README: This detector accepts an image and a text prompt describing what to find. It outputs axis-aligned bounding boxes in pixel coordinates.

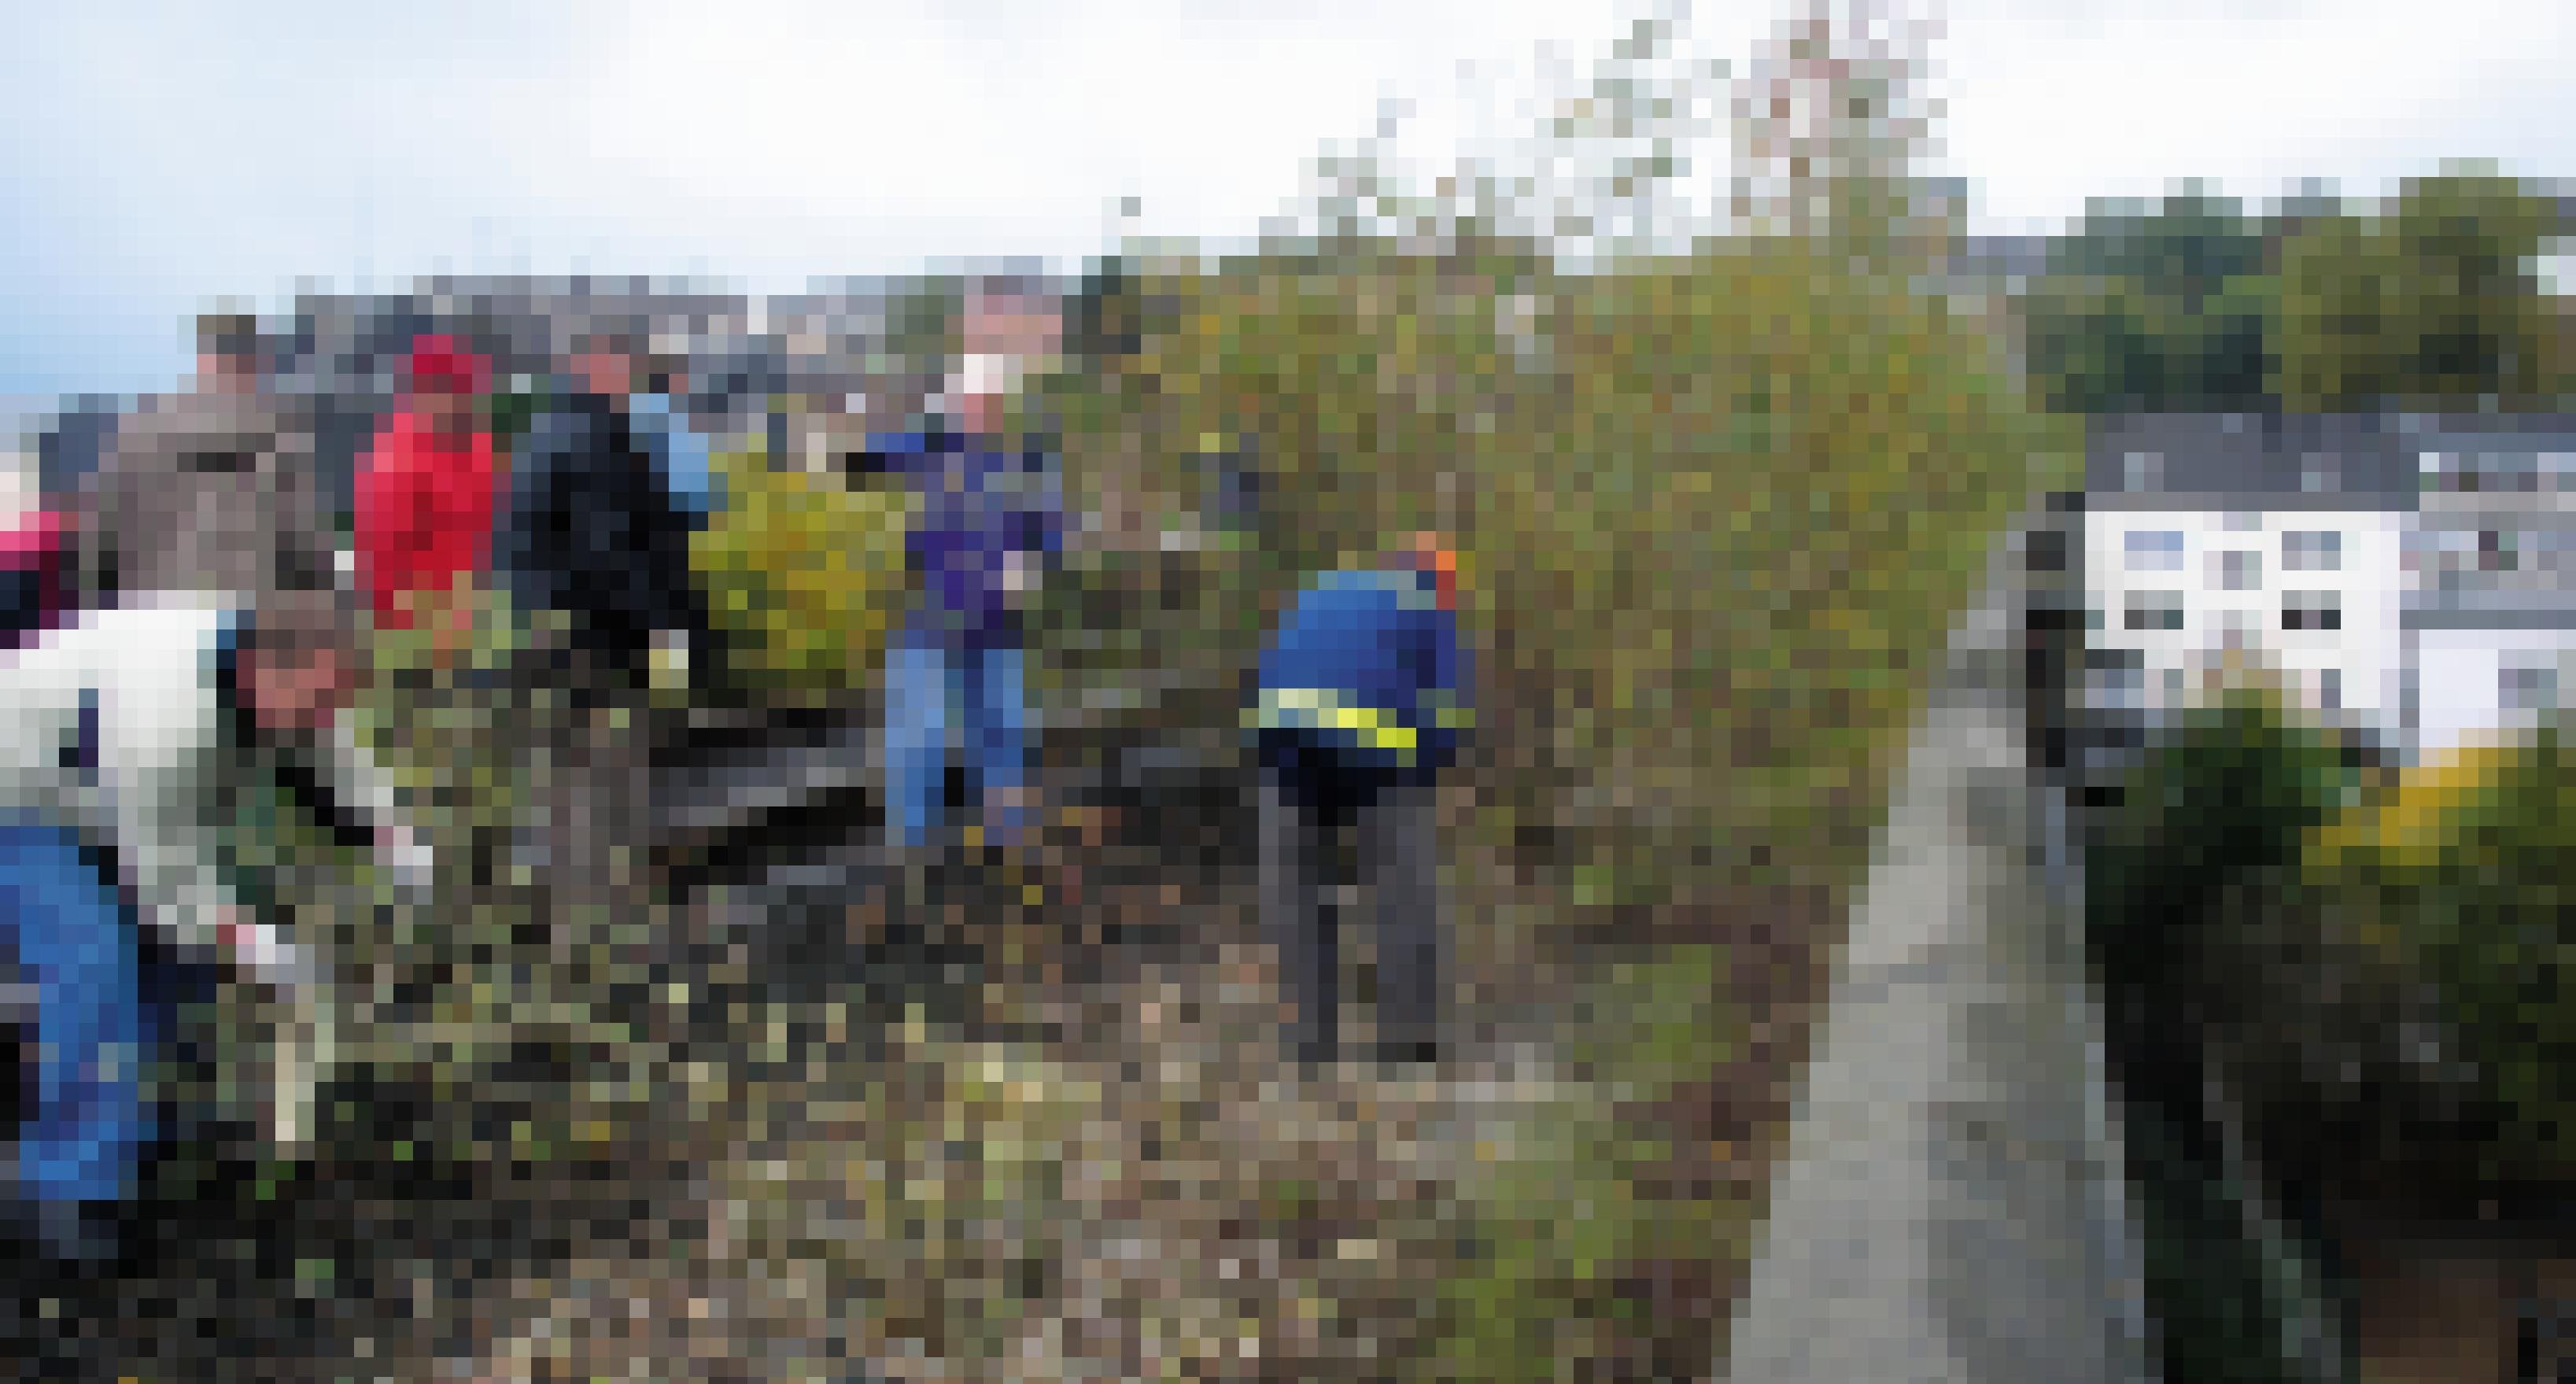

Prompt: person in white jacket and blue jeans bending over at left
[0,592,427,1257]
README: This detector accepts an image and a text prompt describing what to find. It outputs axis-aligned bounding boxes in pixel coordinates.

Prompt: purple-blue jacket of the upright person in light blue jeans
[868,433,1064,649]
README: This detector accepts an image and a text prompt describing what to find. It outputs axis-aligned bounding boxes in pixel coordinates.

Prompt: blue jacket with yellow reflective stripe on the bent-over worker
[1247,562,1474,773]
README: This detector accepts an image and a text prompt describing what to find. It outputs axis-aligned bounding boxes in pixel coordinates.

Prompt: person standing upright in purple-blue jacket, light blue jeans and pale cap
[868,275,1064,853]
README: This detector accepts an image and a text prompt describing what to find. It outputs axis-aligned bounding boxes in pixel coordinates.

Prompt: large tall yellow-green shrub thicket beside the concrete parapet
[1061,245,2074,902]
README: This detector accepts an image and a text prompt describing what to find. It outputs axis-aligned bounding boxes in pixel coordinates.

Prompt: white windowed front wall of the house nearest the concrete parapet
[2084,511,2408,735]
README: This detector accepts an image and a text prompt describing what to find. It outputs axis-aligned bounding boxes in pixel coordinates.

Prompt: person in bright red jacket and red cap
[353,335,495,655]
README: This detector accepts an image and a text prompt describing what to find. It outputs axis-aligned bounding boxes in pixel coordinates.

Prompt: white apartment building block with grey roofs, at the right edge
[2084,415,2576,758]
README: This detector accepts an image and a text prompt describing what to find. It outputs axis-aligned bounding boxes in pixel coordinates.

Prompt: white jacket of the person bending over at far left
[0,596,425,980]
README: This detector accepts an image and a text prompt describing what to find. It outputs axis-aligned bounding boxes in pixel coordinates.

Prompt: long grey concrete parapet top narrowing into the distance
[1718,515,2151,1384]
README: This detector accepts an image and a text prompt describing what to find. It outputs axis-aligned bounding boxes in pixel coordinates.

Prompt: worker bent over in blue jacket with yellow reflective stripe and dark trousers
[1247,533,1471,1065]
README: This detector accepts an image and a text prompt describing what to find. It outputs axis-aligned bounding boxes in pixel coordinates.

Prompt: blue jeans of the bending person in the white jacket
[0,822,157,1201]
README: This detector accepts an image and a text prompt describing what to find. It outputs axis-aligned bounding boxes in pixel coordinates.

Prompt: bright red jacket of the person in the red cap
[350,410,495,629]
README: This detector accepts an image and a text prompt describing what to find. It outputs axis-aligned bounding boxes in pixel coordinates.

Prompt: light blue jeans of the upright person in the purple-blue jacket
[886,634,1028,848]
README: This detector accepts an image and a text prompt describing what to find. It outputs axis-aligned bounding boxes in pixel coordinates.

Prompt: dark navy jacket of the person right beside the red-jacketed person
[495,394,706,667]
